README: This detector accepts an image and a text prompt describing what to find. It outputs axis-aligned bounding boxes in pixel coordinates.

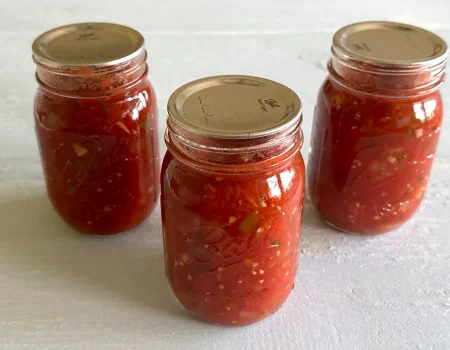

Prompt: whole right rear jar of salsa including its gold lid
[308,22,448,234]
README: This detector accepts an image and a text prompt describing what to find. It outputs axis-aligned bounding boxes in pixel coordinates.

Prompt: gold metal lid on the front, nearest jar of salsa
[167,75,302,139]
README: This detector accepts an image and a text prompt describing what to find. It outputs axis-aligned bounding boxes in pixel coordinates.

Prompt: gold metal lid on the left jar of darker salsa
[32,23,144,68]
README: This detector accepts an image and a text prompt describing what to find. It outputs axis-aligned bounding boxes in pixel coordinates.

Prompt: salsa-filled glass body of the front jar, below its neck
[161,144,305,326]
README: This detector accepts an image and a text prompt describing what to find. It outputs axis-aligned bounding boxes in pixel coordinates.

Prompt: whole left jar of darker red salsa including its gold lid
[33,23,159,234]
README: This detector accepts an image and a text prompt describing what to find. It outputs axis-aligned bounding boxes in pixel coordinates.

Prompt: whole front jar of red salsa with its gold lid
[161,76,305,325]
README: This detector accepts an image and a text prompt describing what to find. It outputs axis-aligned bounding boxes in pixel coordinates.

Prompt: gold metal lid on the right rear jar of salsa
[333,21,448,67]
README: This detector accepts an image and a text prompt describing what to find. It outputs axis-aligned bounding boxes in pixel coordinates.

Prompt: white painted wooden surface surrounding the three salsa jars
[0,0,450,350]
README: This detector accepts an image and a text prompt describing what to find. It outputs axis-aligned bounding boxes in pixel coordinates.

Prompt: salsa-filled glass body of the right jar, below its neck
[308,74,443,234]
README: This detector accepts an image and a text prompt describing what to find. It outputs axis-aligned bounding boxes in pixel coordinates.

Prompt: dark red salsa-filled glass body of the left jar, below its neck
[34,75,159,234]
